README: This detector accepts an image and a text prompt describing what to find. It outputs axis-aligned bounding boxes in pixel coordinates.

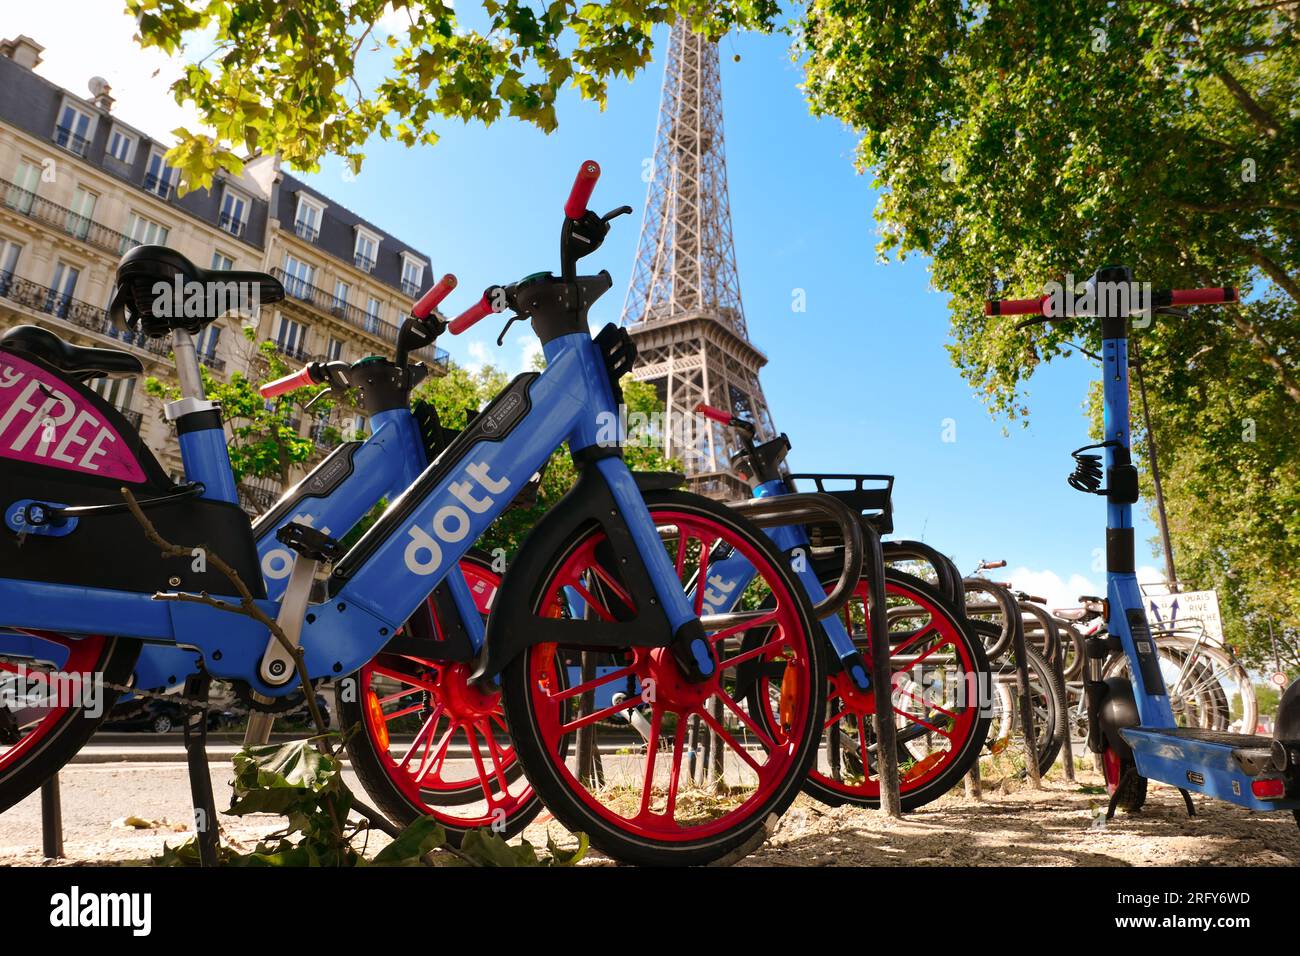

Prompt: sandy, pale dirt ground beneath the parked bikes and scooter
[0,765,1300,866]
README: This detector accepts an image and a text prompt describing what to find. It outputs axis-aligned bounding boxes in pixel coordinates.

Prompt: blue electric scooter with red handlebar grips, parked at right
[985,267,1300,822]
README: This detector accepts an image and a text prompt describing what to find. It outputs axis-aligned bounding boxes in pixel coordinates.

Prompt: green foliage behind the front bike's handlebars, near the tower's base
[412,359,681,557]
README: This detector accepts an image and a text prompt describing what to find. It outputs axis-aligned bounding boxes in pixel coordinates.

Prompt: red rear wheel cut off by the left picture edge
[0,631,140,810]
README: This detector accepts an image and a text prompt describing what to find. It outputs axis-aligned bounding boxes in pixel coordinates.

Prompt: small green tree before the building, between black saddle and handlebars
[144,328,361,488]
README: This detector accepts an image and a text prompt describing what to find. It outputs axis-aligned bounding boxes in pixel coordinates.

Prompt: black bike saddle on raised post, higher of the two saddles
[108,246,285,338]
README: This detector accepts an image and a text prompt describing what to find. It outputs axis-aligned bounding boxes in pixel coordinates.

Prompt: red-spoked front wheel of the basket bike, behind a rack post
[805,571,991,810]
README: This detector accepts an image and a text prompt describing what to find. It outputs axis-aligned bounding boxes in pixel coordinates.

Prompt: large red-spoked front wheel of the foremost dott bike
[503,492,824,865]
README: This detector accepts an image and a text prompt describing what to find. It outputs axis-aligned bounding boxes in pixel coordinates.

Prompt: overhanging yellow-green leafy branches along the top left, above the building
[126,0,779,189]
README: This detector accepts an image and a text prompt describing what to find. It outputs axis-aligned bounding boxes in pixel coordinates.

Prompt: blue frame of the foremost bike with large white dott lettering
[0,333,696,697]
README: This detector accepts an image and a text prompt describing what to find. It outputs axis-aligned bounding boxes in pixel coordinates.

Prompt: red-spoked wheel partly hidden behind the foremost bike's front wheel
[342,557,540,840]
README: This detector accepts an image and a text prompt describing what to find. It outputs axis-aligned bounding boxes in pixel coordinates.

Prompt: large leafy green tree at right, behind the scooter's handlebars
[796,0,1300,660]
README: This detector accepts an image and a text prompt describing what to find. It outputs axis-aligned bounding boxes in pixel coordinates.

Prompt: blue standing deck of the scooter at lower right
[1119,727,1300,810]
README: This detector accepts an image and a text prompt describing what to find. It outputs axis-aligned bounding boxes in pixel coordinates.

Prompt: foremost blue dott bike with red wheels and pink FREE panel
[0,163,824,864]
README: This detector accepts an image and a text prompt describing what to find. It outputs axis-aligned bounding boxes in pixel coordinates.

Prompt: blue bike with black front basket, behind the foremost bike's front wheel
[696,405,991,810]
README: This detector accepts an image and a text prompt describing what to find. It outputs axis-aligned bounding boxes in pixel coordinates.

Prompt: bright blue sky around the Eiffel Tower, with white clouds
[15,0,1158,602]
